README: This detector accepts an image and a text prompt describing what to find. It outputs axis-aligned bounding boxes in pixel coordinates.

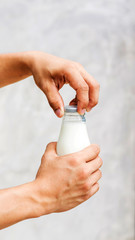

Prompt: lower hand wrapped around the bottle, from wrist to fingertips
[34,143,102,215]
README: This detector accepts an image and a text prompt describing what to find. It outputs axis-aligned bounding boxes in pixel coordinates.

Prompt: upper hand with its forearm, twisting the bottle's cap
[0,51,99,117]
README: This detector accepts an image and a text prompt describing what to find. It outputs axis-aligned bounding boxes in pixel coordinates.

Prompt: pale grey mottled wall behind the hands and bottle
[0,0,135,240]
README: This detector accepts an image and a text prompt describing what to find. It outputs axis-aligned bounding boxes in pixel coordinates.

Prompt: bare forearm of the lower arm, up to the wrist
[0,182,41,229]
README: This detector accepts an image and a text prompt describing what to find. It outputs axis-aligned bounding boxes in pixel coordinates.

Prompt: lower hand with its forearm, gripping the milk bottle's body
[0,142,102,229]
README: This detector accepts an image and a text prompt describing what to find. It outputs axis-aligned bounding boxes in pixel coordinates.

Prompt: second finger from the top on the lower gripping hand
[87,156,103,175]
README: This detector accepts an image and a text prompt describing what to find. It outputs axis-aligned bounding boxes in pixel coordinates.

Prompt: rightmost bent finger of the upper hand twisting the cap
[84,71,100,111]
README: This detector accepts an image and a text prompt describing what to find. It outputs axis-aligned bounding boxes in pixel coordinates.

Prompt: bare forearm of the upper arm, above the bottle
[0,52,32,87]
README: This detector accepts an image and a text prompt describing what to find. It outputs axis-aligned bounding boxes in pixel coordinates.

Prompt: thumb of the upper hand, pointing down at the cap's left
[42,80,64,117]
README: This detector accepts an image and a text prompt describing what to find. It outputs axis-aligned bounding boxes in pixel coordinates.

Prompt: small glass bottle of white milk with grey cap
[56,105,90,156]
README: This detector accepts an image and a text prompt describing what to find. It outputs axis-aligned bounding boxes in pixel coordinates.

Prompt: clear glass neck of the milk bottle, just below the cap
[63,112,86,123]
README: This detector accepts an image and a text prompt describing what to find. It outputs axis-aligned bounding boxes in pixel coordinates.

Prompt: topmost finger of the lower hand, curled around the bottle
[67,144,100,162]
